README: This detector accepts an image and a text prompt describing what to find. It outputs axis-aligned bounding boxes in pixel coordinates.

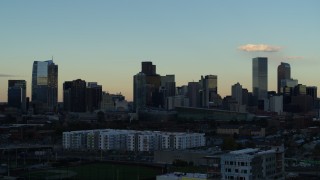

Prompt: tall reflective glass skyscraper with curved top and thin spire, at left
[32,60,58,111]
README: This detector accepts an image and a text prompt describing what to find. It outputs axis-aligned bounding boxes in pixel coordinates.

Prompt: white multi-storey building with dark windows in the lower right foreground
[221,147,284,180]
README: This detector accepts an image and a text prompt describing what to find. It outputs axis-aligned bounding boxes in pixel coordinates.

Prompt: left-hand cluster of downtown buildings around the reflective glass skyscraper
[4,60,128,114]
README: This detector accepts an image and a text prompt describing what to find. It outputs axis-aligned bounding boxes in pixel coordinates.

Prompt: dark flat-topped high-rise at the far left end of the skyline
[8,80,27,112]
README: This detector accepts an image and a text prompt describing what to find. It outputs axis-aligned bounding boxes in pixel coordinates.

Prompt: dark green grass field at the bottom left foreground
[24,163,161,180]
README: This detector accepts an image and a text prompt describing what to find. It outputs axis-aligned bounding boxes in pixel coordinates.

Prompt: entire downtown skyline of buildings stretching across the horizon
[3,57,319,114]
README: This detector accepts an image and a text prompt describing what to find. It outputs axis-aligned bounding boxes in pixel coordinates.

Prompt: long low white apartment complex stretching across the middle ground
[62,129,205,152]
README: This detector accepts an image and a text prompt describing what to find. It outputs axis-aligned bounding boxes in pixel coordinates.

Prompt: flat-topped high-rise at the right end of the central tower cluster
[200,75,218,107]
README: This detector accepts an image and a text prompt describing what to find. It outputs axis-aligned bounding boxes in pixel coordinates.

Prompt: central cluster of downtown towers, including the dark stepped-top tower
[133,61,219,110]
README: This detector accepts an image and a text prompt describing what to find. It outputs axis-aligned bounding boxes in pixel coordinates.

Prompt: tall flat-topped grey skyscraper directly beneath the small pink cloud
[252,57,268,100]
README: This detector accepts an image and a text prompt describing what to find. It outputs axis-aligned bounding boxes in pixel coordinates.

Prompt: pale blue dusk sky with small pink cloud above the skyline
[0,0,320,102]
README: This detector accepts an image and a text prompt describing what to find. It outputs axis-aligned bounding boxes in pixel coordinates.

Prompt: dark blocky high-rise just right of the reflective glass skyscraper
[63,79,87,112]
